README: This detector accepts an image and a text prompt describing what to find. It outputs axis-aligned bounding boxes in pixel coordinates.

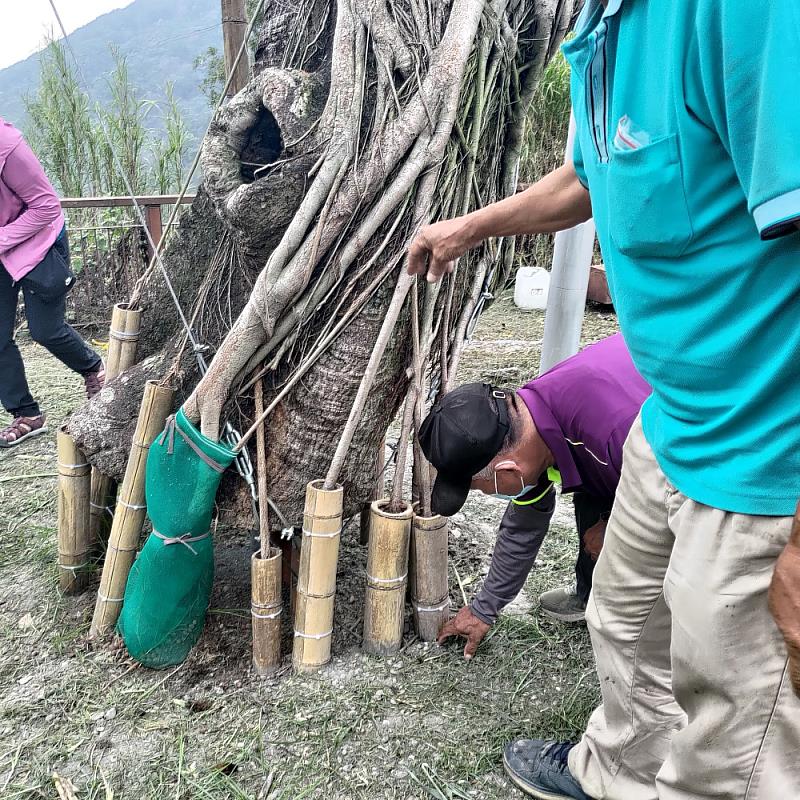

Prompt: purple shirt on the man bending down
[517,333,651,499]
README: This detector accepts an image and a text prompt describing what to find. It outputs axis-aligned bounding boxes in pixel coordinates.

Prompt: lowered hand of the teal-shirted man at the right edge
[769,504,800,697]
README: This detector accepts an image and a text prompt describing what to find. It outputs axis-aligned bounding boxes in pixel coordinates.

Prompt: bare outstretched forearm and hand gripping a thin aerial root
[408,164,592,282]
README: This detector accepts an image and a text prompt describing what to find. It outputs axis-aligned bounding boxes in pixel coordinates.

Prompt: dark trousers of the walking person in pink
[0,236,101,417]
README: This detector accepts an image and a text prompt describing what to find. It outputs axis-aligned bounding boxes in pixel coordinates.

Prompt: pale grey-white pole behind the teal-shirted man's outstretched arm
[539,114,595,375]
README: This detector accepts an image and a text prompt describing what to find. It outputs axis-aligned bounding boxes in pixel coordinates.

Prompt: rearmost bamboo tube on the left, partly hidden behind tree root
[89,303,142,544]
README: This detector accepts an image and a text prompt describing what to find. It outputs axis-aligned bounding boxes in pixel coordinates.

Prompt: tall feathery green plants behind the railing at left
[25,42,191,197]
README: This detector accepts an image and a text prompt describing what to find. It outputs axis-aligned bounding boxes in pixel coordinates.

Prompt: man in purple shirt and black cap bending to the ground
[420,334,650,658]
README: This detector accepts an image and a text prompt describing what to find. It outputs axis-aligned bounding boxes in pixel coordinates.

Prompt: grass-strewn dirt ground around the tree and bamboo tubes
[0,298,616,800]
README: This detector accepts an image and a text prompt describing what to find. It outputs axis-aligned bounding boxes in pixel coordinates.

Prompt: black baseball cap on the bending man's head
[419,383,510,517]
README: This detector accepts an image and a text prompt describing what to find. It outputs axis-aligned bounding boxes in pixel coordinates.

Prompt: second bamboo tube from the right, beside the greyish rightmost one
[363,500,414,656]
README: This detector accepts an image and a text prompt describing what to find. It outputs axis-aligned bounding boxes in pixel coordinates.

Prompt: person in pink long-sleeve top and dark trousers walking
[0,119,105,447]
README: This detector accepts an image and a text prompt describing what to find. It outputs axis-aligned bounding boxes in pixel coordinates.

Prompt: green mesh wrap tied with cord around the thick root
[118,409,236,669]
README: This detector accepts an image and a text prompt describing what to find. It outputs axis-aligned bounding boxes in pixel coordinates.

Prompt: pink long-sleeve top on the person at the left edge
[0,119,64,281]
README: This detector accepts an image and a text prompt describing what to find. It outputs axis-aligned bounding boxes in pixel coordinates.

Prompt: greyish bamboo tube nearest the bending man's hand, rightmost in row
[409,514,450,642]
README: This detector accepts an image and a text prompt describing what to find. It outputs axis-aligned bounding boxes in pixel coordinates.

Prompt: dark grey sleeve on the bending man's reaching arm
[470,488,556,625]
